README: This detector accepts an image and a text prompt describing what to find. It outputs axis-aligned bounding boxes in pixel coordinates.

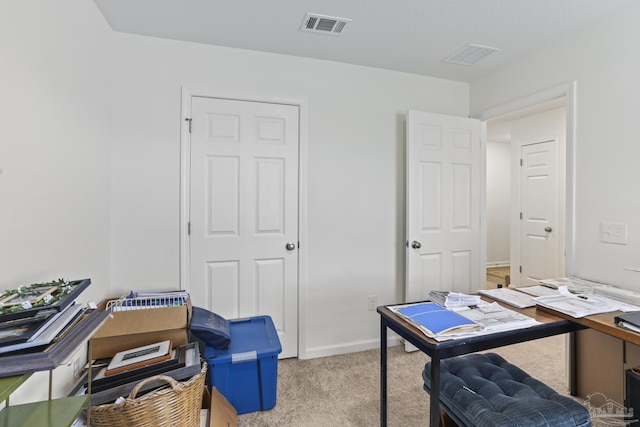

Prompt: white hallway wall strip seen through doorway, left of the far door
[487,141,511,266]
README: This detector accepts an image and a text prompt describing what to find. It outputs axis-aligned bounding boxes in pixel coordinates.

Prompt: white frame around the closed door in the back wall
[179,86,308,359]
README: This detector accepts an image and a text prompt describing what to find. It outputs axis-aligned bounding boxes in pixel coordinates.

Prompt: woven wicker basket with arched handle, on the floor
[88,363,207,427]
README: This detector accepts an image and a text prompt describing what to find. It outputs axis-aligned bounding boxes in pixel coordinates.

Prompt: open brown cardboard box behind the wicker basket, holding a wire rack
[90,298,192,359]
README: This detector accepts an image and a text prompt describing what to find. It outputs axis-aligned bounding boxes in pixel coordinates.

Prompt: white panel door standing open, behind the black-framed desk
[405,111,484,301]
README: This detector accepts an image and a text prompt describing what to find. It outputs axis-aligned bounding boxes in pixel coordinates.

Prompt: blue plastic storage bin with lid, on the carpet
[204,316,282,415]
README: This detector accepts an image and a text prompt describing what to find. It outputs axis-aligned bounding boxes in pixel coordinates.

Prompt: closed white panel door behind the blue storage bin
[189,97,299,357]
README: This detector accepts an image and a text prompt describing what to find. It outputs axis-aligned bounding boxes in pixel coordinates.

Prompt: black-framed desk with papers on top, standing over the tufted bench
[377,306,587,427]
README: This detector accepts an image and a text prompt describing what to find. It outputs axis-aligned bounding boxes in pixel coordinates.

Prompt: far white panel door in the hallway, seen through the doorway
[519,139,562,286]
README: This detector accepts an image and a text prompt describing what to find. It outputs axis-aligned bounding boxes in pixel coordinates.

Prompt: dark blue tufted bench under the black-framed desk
[422,353,591,427]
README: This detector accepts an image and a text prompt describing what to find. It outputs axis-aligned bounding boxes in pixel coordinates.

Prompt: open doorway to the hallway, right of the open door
[482,83,575,286]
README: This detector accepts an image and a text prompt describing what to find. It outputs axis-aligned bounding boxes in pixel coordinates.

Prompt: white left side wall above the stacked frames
[0,0,111,403]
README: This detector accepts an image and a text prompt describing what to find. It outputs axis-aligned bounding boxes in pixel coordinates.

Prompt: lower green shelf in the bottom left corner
[0,395,89,427]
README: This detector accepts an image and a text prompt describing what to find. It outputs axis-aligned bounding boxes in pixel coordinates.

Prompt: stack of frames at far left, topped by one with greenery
[0,279,91,363]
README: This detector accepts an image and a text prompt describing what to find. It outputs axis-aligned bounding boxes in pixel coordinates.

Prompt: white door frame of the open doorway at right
[477,80,577,276]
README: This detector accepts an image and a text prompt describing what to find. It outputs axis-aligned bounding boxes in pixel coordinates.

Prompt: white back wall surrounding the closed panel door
[111,34,468,357]
